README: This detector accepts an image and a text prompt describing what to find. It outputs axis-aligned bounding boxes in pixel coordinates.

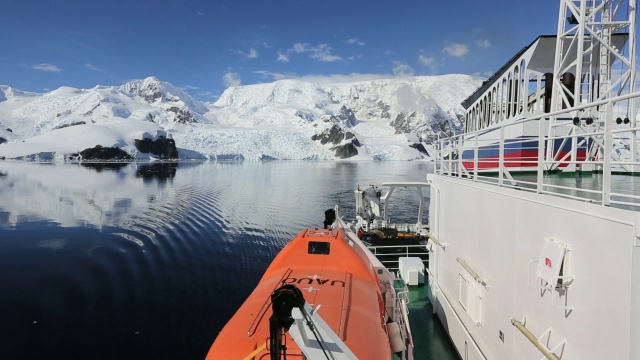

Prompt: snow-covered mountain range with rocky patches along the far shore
[0,75,483,160]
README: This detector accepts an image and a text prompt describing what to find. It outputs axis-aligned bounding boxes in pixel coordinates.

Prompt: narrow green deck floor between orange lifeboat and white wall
[409,285,460,360]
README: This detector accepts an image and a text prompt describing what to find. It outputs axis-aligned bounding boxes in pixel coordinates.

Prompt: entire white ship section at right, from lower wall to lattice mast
[428,0,640,359]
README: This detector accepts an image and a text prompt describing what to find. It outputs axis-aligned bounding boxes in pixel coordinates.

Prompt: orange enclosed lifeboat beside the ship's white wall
[207,229,393,360]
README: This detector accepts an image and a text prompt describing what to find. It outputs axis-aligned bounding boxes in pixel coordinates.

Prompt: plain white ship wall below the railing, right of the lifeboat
[429,175,640,360]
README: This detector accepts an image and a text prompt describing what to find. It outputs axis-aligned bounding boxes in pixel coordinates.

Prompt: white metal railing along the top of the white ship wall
[434,92,640,210]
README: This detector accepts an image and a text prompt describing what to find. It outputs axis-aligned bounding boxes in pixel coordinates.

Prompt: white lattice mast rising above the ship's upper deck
[545,0,637,172]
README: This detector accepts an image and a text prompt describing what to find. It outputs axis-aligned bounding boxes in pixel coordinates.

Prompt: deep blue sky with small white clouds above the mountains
[0,0,559,101]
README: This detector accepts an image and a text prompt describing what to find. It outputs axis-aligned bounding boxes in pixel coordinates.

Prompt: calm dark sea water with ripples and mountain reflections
[0,162,432,359]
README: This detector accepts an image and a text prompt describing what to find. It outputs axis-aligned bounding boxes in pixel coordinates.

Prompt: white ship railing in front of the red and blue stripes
[434,92,640,211]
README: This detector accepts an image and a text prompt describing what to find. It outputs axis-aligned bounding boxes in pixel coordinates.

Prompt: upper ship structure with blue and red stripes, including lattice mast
[458,1,637,177]
